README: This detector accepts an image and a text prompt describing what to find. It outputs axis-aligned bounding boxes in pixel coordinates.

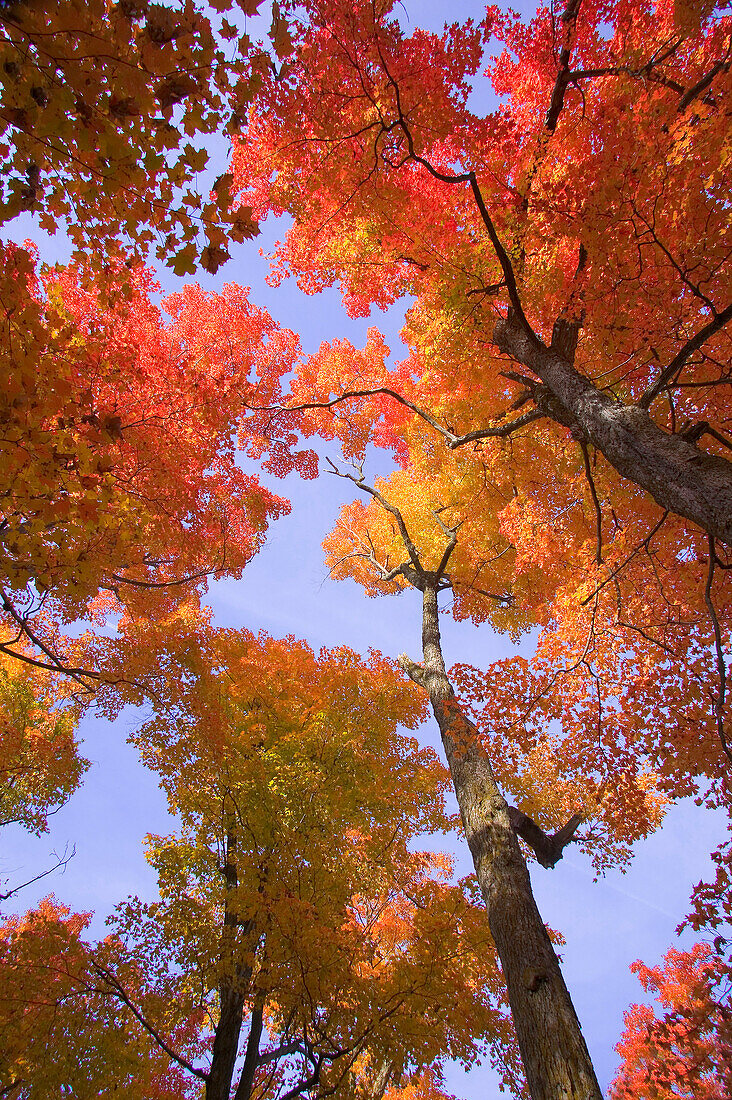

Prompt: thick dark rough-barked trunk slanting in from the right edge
[493,318,732,545]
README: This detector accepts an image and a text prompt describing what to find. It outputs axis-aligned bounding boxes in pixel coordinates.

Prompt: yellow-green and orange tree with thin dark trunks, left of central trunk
[0,613,522,1100]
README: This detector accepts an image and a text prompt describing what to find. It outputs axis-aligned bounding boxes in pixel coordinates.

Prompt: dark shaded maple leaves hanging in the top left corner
[0,0,287,274]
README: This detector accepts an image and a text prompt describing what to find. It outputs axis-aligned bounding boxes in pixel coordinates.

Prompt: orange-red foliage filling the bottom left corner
[0,898,195,1100]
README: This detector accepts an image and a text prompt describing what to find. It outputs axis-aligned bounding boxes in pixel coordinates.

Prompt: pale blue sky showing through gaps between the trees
[0,0,724,1100]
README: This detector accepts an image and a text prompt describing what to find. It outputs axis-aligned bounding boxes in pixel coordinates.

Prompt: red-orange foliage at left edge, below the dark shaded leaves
[0,246,312,682]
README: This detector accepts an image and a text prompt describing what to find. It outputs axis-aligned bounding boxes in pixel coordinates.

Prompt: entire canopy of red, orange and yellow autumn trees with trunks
[0,0,732,1100]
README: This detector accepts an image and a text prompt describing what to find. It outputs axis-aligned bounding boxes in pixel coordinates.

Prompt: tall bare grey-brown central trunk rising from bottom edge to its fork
[405,585,602,1100]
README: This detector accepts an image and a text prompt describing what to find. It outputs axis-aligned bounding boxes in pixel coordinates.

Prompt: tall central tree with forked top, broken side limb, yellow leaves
[317,474,601,1098]
